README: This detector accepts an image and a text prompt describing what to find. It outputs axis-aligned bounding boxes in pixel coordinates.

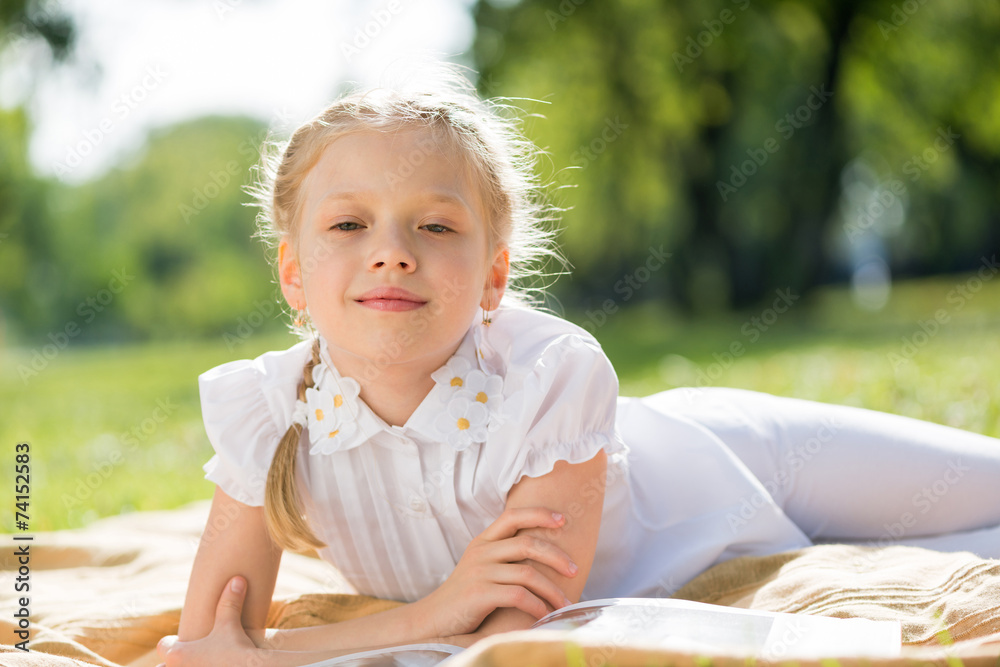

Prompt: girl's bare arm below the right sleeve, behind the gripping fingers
[474,449,608,638]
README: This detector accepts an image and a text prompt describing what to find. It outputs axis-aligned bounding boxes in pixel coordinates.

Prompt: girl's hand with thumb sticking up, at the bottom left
[156,577,257,667]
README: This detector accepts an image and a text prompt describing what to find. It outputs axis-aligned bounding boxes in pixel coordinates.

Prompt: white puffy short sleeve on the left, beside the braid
[198,344,308,507]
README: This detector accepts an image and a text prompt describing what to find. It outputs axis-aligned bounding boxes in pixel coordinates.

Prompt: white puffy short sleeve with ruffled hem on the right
[491,333,625,498]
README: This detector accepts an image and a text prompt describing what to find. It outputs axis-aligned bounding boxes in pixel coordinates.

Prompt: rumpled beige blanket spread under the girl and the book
[0,502,1000,667]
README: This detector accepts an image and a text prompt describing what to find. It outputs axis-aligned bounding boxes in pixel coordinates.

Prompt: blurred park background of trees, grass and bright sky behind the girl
[0,0,1000,529]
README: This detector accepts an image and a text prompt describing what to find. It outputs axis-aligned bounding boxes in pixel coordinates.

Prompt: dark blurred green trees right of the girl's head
[474,0,1000,310]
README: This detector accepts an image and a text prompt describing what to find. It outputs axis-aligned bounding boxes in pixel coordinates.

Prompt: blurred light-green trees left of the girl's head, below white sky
[0,112,278,347]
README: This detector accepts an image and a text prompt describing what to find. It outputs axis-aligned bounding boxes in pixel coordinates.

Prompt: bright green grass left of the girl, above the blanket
[0,334,295,531]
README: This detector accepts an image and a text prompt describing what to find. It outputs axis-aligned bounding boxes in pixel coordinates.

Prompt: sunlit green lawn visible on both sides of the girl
[0,276,1000,532]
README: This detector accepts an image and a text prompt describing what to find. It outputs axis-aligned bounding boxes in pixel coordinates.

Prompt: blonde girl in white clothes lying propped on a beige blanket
[160,69,1000,665]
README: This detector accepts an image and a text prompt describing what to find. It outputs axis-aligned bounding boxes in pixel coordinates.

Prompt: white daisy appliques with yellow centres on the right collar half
[431,357,503,451]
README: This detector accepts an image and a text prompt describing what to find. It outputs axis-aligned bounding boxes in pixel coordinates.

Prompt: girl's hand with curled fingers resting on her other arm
[413,507,577,637]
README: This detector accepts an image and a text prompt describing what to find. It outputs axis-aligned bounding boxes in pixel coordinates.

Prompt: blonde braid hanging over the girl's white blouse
[264,338,326,552]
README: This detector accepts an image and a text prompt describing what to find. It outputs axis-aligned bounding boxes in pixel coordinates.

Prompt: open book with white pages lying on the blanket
[300,598,900,667]
